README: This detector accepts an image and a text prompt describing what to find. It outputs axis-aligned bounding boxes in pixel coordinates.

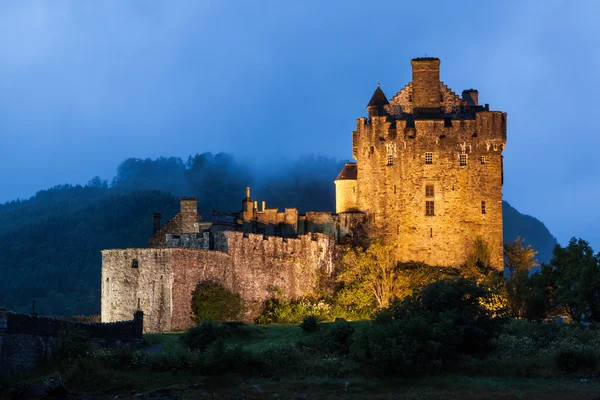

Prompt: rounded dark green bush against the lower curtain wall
[192,281,244,323]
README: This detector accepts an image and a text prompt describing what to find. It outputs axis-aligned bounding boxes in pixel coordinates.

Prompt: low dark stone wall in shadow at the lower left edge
[0,309,143,376]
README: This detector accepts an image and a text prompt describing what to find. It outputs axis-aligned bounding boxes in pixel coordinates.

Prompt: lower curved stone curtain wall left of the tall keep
[101,232,335,332]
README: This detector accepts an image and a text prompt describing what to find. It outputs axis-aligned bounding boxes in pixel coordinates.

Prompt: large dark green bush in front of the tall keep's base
[352,278,497,376]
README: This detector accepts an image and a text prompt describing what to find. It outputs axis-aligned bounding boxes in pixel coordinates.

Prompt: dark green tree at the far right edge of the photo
[550,238,600,322]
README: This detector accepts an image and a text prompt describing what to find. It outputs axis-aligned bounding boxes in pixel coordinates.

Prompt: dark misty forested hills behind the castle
[0,153,556,315]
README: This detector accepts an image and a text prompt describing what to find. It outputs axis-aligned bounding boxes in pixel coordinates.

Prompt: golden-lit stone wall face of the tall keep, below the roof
[353,111,506,269]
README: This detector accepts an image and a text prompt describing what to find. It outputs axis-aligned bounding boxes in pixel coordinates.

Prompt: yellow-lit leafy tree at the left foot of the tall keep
[338,239,398,308]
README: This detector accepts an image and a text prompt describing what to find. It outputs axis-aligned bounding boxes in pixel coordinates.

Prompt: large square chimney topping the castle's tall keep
[410,57,441,111]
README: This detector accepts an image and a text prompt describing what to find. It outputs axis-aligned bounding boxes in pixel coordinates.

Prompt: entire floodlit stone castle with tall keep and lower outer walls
[101,58,506,332]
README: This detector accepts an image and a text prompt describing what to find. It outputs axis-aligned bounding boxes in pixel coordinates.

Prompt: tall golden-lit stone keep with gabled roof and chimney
[335,58,506,269]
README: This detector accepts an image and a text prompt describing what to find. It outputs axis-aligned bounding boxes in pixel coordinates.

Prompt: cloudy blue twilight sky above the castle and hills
[0,0,600,251]
